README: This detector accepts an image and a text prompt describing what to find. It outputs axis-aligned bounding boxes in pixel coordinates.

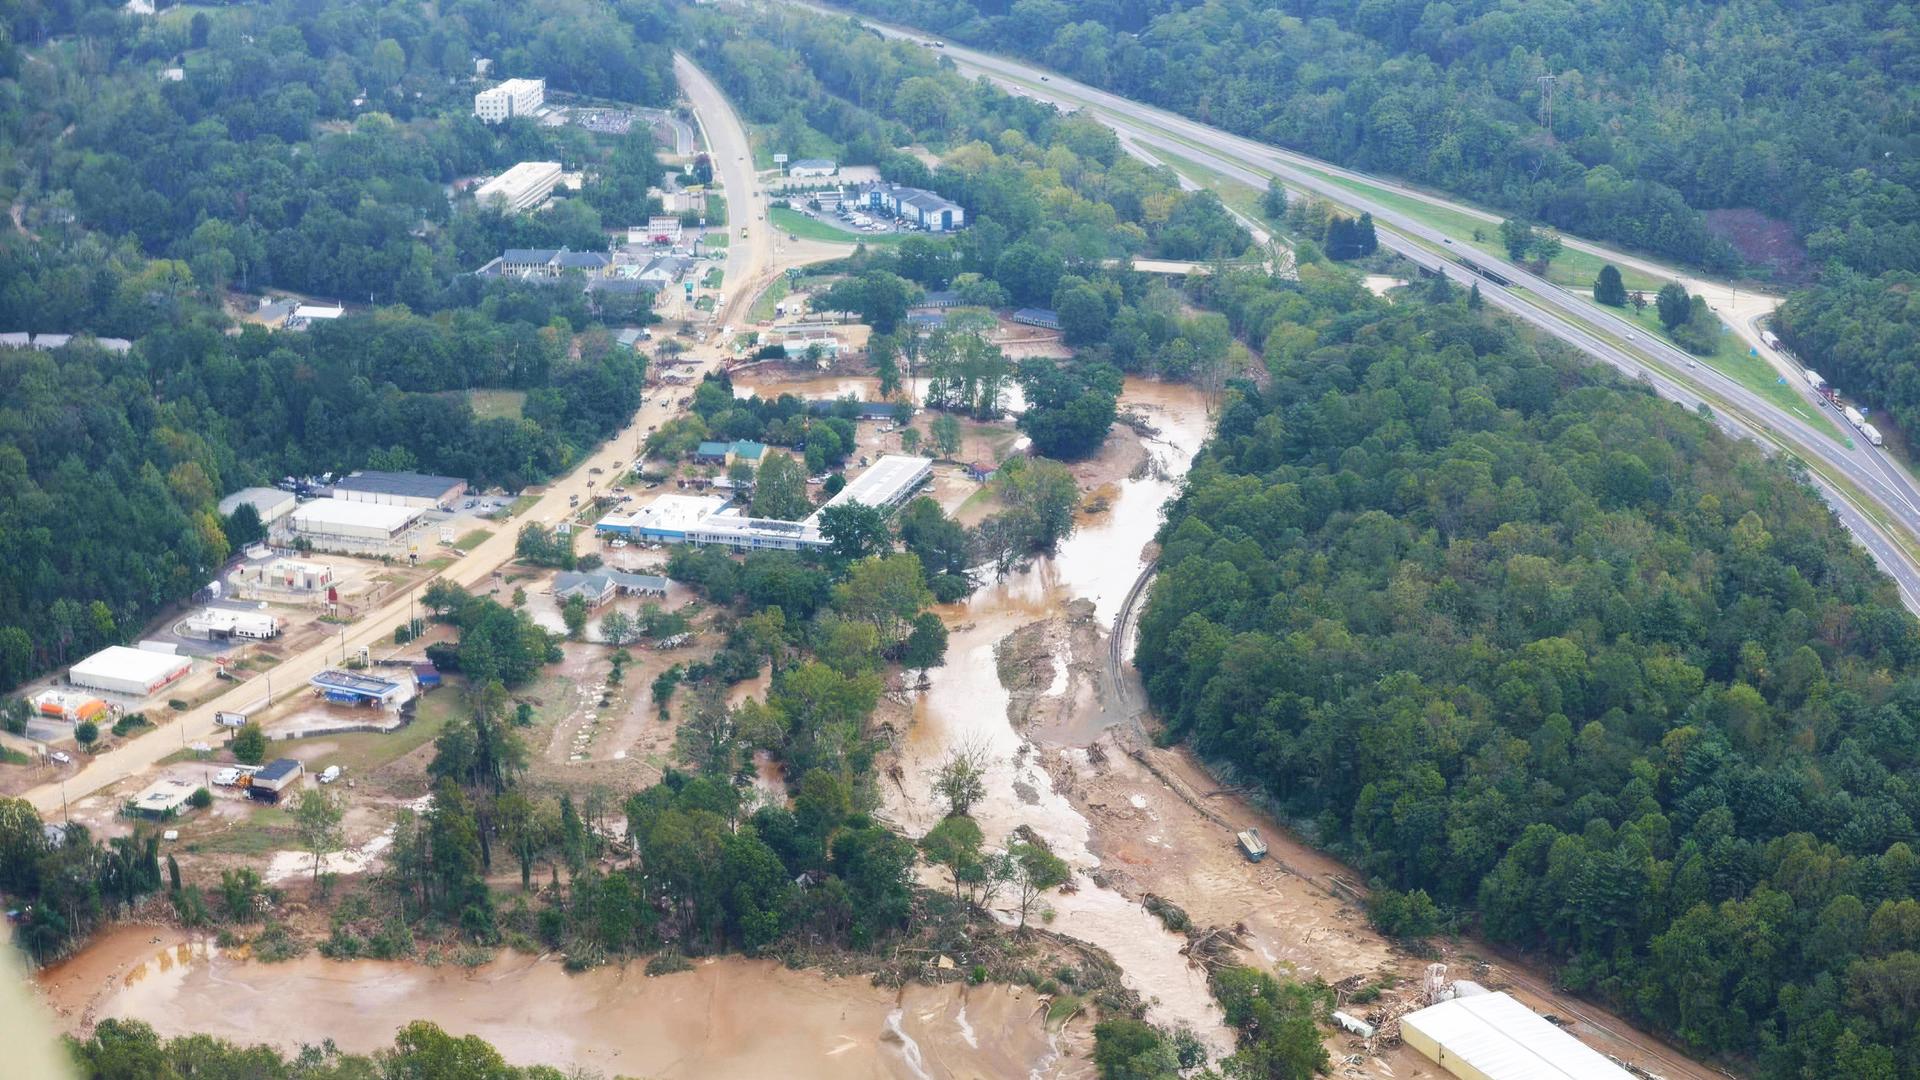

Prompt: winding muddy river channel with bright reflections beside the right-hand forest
[885,379,1231,1051]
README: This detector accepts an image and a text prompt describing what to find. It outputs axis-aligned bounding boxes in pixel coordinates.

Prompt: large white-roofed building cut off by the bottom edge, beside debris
[1400,984,1632,1080]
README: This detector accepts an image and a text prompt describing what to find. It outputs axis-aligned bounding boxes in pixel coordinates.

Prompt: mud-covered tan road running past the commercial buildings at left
[27,58,774,817]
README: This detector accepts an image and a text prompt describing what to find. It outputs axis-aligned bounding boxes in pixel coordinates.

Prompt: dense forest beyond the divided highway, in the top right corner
[849,0,1920,438]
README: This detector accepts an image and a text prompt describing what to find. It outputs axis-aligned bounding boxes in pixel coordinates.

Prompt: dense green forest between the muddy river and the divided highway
[1137,265,1920,1078]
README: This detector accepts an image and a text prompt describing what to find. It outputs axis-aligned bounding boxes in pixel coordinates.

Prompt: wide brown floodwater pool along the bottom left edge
[67,928,1089,1080]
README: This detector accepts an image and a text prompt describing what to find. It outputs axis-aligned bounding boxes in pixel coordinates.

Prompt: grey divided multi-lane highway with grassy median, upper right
[789,0,1920,613]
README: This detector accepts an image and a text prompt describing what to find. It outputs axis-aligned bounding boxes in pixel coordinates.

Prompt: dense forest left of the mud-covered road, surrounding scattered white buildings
[0,0,672,688]
